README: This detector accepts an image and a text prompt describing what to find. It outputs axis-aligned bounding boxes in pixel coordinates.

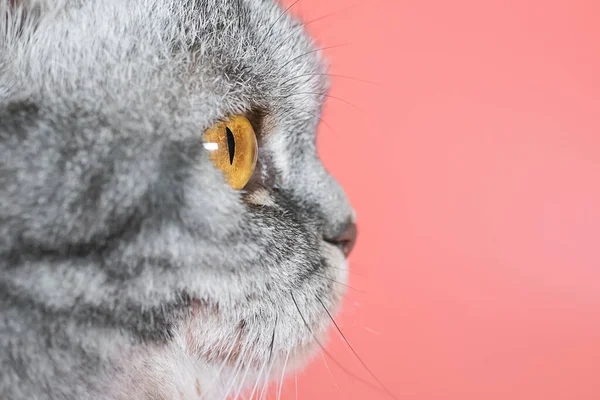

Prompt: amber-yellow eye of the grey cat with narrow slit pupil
[204,115,258,189]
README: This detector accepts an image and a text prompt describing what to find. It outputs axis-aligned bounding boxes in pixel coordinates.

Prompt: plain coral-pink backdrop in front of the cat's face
[274,0,600,400]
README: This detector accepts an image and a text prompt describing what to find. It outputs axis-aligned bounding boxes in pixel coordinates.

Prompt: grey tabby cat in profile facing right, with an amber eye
[0,0,356,400]
